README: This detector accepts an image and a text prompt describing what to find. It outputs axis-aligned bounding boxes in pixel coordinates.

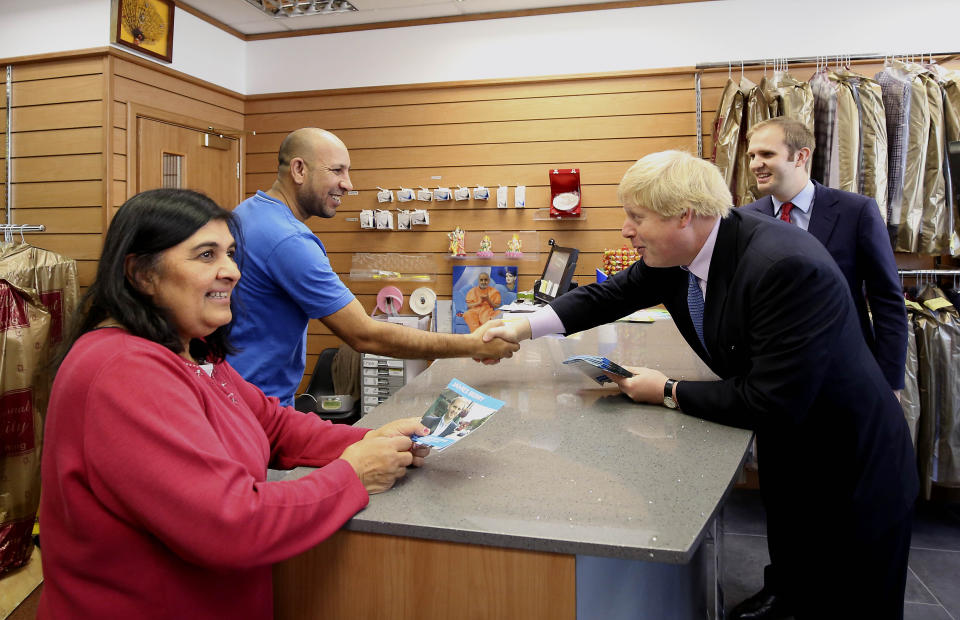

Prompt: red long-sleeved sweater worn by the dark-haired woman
[38,328,368,619]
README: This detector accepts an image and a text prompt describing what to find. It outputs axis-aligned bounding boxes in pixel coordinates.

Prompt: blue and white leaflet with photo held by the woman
[413,379,503,452]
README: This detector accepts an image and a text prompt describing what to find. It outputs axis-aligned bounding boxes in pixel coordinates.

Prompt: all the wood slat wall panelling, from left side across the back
[9,48,960,398]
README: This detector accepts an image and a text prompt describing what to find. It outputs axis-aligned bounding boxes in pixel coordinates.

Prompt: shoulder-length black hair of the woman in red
[58,189,241,361]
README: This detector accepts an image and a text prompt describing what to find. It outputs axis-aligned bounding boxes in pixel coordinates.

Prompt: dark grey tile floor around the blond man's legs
[721,489,960,620]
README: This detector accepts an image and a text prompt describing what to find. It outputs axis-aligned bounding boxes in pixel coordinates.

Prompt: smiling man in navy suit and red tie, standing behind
[731,117,907,620]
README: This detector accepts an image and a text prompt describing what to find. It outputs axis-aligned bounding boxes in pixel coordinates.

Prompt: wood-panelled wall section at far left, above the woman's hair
[0,56,109,286]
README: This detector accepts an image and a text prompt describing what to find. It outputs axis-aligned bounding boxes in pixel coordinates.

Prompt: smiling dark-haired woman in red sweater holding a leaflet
[39,190,429,618]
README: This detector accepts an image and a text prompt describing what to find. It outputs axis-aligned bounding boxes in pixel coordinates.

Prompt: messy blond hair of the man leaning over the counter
[617,151,733,217]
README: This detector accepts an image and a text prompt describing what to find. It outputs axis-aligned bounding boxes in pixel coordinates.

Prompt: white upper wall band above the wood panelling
[0,0,960,94]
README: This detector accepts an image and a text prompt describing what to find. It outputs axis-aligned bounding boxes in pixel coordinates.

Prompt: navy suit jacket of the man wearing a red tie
[740,181,907,390]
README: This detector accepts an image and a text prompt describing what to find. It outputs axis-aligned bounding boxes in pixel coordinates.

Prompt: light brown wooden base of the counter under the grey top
[273,530,577,620]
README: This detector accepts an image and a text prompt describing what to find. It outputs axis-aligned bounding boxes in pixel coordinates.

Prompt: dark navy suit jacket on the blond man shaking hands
[551,209,918,536]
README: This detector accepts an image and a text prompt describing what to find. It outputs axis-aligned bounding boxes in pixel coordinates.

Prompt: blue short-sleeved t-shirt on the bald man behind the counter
[227,191,354,405]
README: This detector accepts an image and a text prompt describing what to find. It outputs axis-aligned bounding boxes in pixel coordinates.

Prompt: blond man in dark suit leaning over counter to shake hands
[484,151,918,619]
